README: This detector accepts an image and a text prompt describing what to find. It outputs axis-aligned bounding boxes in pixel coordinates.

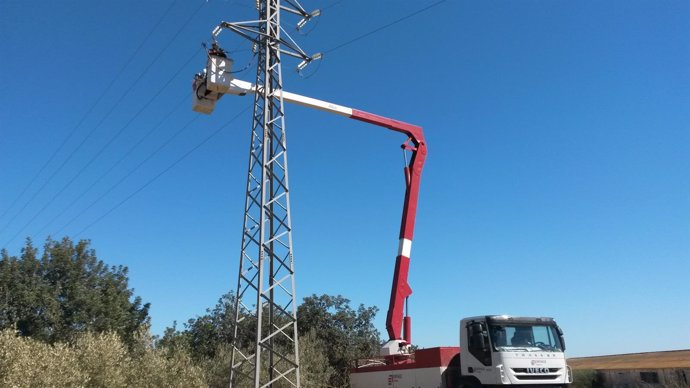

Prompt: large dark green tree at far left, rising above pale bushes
[0,237,150,345]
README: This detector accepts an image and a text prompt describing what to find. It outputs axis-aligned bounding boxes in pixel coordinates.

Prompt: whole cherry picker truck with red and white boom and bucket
[192,46,573,388]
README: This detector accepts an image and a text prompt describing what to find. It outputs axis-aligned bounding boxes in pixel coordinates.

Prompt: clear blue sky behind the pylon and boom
[0,0,690,356]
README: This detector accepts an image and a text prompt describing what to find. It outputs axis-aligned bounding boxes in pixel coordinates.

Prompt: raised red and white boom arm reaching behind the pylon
[206,79,427,355]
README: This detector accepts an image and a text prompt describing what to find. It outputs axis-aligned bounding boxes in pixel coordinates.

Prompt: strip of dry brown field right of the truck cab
[568,349,690,369]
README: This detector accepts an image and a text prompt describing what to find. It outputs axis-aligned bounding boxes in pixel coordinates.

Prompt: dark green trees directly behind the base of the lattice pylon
[158,293,380,388]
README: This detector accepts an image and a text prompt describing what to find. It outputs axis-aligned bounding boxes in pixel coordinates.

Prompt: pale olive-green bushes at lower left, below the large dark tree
[0,330,207,388]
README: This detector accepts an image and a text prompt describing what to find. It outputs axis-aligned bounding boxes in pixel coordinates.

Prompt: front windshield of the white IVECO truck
[489,324,563,352]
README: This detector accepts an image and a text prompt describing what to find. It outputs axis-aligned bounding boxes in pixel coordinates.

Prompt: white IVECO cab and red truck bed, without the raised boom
[350,315,573,388]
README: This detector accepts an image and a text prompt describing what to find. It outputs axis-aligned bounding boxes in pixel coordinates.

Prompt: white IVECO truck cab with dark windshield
[459,315,572,387]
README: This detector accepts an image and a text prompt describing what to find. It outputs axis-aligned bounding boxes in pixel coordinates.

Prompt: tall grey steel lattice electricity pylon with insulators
[195,0,320,388]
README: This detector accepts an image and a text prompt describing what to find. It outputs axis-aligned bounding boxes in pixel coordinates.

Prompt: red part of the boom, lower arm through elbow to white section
[351,109,427,343]
